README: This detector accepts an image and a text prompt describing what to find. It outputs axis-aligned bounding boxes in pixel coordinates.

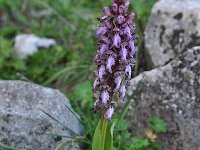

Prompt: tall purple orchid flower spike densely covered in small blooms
[93,0,137,121]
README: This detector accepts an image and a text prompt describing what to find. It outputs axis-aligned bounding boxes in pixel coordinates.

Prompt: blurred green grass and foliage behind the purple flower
[0,0,162,150]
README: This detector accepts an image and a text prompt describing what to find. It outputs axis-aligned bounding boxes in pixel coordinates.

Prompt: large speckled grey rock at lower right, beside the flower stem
[128,47,200,150]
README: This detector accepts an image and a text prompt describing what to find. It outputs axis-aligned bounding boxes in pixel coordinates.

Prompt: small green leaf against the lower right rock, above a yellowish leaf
[148,117,167,133]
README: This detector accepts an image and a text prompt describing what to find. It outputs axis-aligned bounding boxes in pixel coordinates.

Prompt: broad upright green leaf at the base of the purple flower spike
[92,117,116,150]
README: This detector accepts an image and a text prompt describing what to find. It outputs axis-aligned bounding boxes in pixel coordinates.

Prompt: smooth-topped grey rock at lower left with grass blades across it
[0,81,82,150]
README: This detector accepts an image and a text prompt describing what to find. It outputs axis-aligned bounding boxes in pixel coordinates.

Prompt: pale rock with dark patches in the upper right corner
[145,0,200,67]
